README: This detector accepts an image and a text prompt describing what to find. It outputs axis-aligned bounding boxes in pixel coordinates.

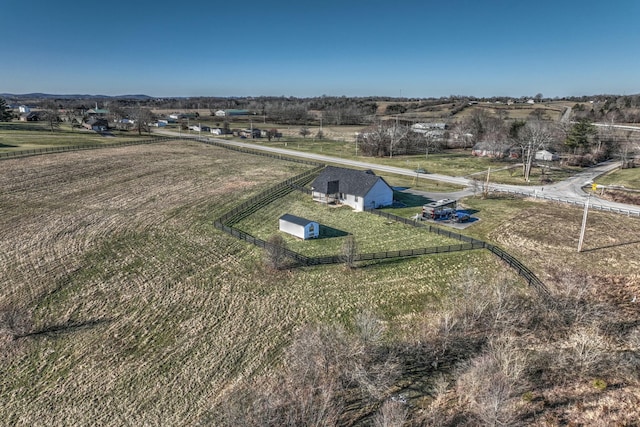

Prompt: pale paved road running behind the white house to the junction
[155,130,640,216]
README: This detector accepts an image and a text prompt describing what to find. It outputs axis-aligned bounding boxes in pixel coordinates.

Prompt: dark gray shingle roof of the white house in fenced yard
[311,166,389,197]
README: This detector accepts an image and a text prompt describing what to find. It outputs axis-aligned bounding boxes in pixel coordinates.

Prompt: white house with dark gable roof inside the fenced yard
[311,166,393,211]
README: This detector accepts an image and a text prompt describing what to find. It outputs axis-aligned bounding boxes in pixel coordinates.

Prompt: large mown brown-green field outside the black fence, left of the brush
[0,142,507,425]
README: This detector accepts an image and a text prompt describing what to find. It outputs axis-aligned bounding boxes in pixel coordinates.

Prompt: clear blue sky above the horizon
[0,0,640,97]
